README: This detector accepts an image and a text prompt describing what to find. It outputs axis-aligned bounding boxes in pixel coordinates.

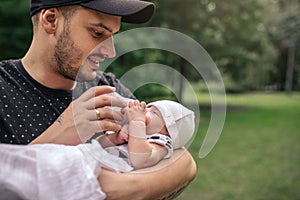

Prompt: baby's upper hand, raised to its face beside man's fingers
[127,100,146,122]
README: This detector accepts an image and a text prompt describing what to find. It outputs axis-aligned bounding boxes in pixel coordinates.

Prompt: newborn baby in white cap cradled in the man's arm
[97,100,195,169]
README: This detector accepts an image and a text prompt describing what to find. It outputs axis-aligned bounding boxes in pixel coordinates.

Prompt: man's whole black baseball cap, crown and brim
[30,0,154,24]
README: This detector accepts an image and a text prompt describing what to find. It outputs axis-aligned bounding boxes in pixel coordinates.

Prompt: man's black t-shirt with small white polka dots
[0,60,134,144]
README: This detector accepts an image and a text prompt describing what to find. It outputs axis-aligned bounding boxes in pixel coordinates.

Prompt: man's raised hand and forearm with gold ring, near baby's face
[31,86,126,145]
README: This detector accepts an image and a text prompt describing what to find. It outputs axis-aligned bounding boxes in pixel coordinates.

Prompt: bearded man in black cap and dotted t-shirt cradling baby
[0,0,196,199]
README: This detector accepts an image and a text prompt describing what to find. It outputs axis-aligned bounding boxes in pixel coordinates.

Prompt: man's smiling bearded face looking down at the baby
[54,8,121,81]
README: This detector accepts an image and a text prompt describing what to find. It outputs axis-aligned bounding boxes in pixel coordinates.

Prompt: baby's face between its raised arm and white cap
[145,106,168,135]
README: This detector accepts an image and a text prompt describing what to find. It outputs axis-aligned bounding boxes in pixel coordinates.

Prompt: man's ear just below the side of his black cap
[40,8,59,34]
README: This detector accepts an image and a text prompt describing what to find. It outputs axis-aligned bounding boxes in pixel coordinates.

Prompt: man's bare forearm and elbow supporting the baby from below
[98,149,197,200]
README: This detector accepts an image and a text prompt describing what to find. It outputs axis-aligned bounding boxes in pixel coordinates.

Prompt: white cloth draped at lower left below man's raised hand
[0,144,105,200]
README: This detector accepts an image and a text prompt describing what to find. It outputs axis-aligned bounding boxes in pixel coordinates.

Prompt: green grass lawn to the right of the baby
[177,93,300,200]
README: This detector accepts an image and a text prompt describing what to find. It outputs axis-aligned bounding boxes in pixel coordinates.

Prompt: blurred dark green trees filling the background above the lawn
[0,0,300,97]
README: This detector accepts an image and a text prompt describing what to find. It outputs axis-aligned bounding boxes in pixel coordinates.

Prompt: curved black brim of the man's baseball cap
[80,0,154,24]
